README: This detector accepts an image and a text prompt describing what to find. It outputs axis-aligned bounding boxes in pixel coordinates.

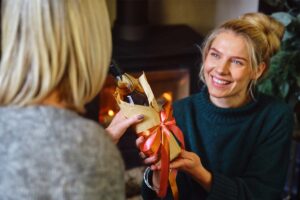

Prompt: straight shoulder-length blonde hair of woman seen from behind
[0,0,112,111]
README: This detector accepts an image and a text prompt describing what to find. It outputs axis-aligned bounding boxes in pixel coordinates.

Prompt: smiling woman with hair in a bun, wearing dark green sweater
[141,13,293,200]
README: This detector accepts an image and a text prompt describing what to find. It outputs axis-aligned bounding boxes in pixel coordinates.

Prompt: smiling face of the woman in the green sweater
[203,31,254,108]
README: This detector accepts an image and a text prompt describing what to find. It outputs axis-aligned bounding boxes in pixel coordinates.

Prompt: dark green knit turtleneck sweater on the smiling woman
[143,88,293,200]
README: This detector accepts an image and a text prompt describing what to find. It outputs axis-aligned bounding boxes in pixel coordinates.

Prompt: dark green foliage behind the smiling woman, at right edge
[258,11,300,101]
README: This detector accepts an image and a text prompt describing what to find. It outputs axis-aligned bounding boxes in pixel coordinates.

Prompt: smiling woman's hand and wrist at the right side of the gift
[170,150,212,192]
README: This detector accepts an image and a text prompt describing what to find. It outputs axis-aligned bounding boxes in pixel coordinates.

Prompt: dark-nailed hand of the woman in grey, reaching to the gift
[106,111,144,143]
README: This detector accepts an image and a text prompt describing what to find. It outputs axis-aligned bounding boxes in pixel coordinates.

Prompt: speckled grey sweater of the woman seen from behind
[0,106,125,200]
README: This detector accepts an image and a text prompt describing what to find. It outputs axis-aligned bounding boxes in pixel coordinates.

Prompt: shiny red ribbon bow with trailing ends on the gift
[140,103,184,199]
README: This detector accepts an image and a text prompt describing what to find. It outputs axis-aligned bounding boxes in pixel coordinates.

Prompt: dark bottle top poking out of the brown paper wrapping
[109,61,149,106]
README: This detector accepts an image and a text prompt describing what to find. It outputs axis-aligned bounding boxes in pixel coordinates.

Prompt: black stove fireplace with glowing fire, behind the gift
[87,0,203,169]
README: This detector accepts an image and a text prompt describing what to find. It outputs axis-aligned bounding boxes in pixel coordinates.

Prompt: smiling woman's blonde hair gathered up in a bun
[200,13,284,92]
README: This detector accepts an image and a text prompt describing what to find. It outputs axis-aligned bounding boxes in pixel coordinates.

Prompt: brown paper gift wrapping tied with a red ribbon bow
[115,73,184,197]
